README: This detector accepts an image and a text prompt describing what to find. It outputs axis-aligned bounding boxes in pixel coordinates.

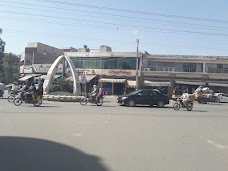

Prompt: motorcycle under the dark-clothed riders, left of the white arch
[13,91,42,107]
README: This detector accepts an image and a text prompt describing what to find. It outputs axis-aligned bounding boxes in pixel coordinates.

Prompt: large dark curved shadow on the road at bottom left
[0,137,108,171]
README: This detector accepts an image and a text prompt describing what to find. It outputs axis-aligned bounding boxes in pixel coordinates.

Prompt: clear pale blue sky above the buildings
[0,0,228,56]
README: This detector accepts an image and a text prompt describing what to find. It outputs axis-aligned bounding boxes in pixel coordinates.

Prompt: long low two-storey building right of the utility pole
[142,54,228,94]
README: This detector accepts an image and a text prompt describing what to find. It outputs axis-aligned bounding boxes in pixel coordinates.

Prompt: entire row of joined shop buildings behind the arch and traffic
[20,43,228,94]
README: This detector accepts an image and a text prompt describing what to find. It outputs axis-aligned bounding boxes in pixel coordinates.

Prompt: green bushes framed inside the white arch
[51,78,73,93]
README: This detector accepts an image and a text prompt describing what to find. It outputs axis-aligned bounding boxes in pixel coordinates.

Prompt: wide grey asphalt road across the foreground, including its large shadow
[0,97,228,171]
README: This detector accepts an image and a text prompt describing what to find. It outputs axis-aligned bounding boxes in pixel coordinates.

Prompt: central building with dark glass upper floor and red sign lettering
[65,46,142,94]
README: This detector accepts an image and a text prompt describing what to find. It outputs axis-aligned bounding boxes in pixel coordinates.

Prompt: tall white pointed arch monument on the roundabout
[43,55,81,95]
